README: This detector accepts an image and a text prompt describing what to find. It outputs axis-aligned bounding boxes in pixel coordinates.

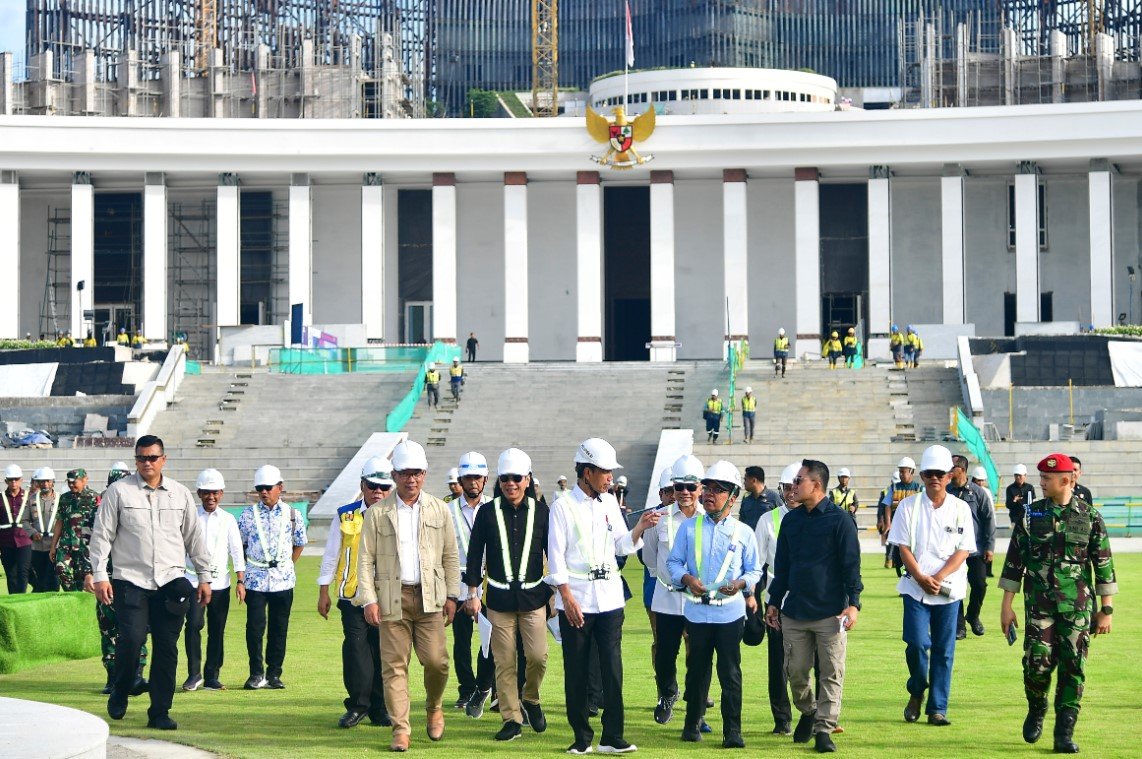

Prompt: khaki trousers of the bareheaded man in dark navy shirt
[781,616,849,735]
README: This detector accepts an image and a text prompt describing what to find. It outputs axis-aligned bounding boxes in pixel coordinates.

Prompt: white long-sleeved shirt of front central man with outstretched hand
[547,485,643,614]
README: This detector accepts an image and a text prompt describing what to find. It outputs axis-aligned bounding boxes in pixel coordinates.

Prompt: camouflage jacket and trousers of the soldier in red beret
[999,499,1118,713]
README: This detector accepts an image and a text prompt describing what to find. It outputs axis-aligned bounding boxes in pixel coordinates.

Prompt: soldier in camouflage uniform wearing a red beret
[999,453,1118,753]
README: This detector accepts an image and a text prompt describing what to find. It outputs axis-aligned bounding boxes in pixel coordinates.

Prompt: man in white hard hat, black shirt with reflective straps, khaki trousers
[465,449,552,741]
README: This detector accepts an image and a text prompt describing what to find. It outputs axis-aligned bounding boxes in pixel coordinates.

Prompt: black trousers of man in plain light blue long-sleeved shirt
[686,619,746,735]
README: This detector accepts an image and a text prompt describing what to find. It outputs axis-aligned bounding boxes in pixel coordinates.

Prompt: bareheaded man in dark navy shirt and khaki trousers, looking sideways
[765,459,864,753]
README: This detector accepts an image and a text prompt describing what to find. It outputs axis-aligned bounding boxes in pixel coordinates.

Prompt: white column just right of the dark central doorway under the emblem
[650,171,678,361]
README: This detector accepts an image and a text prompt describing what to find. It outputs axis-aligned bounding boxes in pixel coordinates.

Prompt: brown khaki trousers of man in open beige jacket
[380,586,448,735]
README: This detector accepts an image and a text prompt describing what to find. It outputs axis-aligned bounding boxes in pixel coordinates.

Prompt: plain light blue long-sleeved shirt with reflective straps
[666,516,762,624]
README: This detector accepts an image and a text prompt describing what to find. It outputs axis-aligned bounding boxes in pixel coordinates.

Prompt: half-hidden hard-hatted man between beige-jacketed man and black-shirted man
[445,451,496,719]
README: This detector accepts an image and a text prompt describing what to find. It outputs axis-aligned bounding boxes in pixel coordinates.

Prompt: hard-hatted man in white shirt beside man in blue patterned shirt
[183,469,246,691]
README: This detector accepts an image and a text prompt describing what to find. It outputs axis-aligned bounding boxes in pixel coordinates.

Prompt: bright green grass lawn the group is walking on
[0,555,1142,758]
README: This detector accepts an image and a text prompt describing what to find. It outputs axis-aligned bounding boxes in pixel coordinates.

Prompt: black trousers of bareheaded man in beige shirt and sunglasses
[111,580,185,719]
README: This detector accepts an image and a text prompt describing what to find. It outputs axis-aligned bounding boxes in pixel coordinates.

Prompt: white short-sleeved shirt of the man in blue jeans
[888,491,975,606]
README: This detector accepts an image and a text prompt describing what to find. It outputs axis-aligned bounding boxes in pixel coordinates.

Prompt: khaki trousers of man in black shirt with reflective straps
[488,606,547,725]
